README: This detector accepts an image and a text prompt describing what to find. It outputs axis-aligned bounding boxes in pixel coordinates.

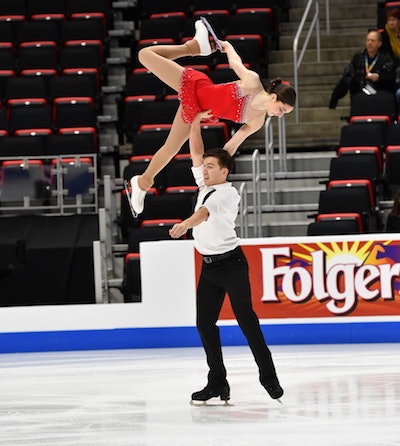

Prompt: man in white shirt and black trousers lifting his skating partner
[170,110,283,402]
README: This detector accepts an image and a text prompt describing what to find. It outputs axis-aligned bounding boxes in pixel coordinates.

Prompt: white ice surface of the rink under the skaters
[0,344,400,446]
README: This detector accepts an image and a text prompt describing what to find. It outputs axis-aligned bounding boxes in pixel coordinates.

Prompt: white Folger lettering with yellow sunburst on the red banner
[260,241,400,315]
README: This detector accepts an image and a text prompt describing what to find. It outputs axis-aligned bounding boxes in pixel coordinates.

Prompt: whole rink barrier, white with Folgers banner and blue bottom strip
[0,234,400,353]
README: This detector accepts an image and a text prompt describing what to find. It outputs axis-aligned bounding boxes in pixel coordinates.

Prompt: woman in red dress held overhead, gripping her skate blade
[126,18,296,216]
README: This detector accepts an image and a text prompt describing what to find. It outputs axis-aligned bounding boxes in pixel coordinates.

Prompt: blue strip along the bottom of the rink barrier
[0,321,400,353]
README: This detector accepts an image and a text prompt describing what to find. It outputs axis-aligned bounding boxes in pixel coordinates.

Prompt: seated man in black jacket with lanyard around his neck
[329,30,395,109]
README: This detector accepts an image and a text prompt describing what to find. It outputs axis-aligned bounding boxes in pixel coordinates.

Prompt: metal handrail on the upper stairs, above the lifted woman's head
[293,0,322,124]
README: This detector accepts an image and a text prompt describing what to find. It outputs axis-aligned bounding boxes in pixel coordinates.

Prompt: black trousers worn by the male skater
[196,247,277,386]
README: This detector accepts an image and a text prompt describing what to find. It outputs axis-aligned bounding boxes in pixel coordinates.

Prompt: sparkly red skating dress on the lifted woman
[179,68,250,123]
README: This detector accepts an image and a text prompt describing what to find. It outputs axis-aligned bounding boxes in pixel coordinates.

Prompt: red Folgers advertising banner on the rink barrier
[197,239,400,319]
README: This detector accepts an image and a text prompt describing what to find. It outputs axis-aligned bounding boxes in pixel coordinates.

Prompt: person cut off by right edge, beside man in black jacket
[382,8,400,111]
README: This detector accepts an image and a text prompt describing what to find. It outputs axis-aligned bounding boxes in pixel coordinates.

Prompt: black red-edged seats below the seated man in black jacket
[308,84,400,235]
